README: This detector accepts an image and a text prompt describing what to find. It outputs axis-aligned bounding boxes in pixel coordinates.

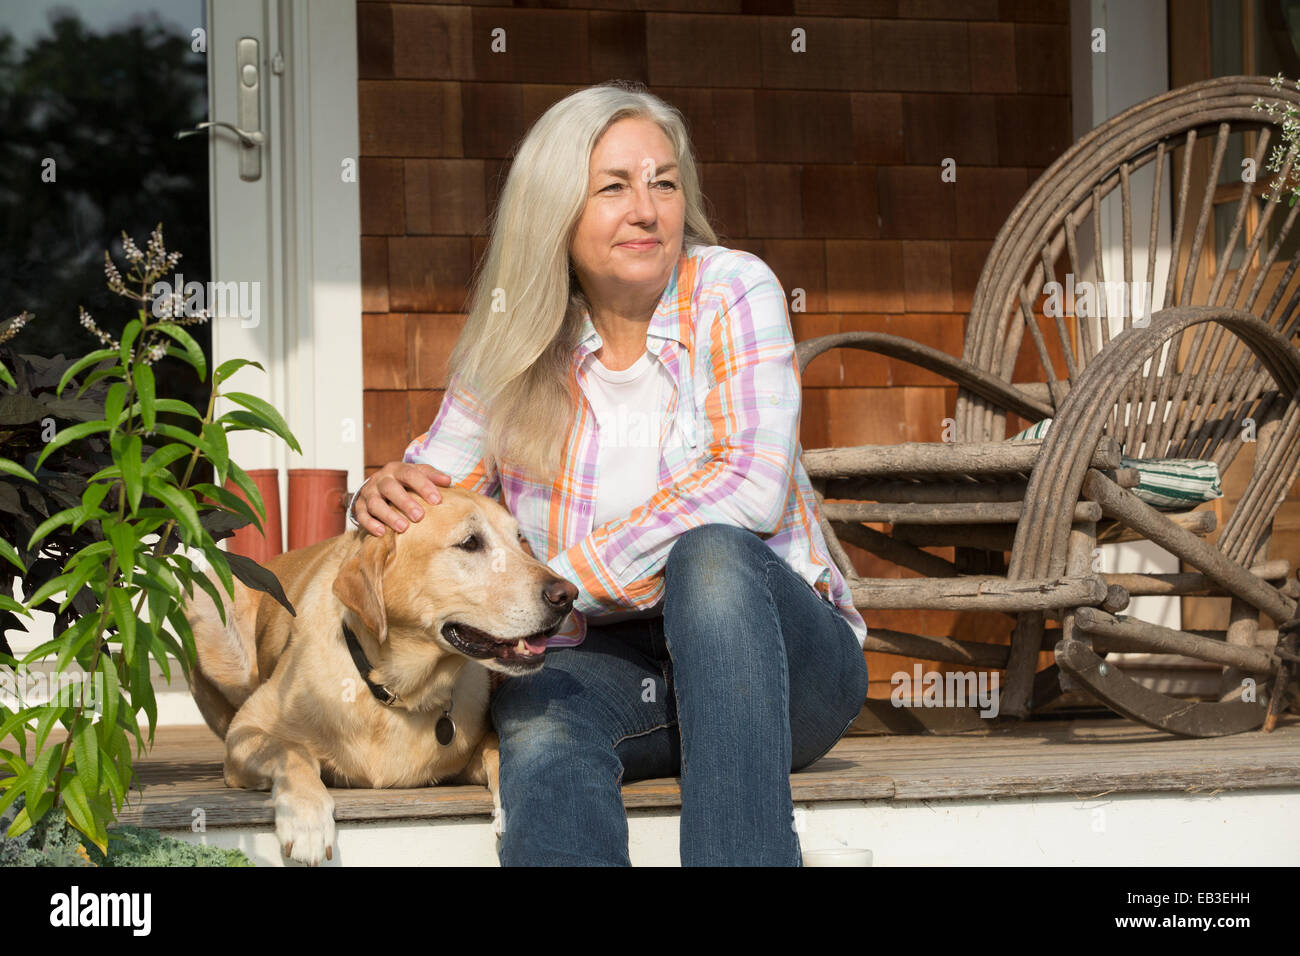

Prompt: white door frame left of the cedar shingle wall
[208,0,364,530]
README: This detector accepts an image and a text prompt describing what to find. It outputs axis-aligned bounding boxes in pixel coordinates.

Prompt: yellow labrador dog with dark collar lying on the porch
[186,488,577,865]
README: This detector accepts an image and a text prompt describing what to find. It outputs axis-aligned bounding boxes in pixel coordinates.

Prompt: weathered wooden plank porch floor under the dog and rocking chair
[51,714,1300,829]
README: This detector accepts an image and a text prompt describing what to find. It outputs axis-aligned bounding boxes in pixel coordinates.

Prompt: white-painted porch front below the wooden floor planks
[164,788,1300,868]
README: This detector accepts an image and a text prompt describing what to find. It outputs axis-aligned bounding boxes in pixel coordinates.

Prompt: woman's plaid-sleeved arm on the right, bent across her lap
[549,255,802,613]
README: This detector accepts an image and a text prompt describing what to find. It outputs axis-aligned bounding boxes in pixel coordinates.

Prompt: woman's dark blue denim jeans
[491,524,867,866]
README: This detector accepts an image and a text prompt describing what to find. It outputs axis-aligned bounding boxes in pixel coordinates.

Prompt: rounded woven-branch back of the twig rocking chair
[956,77,1300,494]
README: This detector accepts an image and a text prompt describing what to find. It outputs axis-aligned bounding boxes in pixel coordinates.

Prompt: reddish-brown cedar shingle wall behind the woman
[358,0,1071,696]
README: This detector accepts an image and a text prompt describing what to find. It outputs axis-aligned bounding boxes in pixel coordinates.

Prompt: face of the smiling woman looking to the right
[569,117,686,310]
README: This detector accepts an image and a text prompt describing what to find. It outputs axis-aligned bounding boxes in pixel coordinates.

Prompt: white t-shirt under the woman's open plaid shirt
[586,351,672,627]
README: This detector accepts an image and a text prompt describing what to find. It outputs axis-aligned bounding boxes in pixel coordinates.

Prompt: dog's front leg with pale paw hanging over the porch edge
[226,717,334,866]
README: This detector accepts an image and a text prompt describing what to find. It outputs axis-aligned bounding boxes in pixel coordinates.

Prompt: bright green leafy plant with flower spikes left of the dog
[0,225,300,853]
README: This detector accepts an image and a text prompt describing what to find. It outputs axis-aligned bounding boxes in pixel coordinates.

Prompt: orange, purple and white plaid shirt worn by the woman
[404,246,867,646]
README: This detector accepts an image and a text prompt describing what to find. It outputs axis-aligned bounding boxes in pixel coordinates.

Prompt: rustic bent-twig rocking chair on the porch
[797,77,1300,736]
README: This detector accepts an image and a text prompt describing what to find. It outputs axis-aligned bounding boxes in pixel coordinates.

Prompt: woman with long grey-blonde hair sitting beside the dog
[354,83,867,866]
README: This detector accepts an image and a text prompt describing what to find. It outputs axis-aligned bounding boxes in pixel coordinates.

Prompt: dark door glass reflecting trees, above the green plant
[0,0,211,407]
